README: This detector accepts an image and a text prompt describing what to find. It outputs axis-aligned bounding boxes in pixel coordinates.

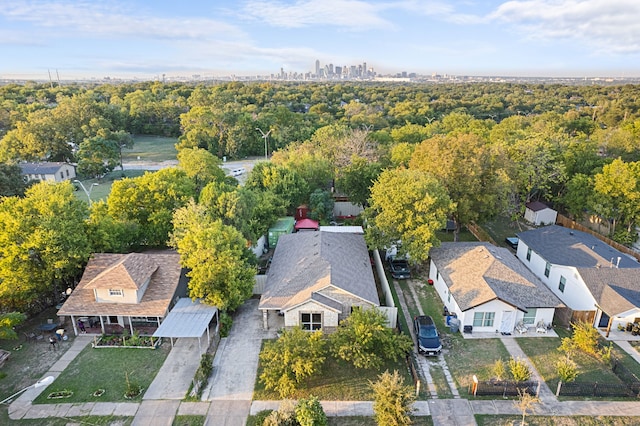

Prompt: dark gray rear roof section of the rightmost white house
[517,225,640,268]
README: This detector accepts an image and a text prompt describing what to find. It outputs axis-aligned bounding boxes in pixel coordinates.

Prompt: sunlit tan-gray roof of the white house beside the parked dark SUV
[430,242,562,312]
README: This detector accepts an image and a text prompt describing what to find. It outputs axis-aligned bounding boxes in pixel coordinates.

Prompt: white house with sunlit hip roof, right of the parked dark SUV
[429,242,563,333]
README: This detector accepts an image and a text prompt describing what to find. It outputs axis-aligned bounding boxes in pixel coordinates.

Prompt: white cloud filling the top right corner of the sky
[489,0,640,54]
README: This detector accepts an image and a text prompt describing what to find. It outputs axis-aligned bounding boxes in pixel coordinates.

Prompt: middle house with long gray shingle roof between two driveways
[258,231,380,332]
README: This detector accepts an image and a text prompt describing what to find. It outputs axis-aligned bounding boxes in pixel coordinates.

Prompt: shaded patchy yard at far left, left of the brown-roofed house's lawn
[0,308,73,404]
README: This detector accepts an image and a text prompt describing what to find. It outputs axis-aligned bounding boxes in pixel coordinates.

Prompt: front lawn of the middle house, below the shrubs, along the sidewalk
[253,348,413,401]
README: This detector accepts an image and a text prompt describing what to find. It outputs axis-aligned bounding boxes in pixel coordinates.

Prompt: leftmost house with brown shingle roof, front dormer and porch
[58,250,186,335]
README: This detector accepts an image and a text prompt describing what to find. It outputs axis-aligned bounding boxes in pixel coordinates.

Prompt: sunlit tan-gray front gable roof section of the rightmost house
[578,267,640,316]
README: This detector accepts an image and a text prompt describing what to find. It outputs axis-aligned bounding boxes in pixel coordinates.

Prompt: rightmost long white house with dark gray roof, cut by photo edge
[517,225,640,327]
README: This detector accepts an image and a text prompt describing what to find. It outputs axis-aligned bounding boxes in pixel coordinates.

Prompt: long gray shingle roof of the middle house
[259,231,380,310]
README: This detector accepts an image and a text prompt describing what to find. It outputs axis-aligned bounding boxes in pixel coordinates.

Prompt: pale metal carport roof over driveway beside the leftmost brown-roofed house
[153,297,218,338]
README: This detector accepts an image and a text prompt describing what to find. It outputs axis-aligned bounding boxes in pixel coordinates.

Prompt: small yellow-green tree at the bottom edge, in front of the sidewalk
[370,370,415,426]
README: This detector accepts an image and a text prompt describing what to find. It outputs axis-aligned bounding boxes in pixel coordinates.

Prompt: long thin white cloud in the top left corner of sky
[0,0,243,39]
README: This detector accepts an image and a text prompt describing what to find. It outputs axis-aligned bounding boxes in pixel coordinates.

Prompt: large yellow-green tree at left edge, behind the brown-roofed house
[0,182,91,312]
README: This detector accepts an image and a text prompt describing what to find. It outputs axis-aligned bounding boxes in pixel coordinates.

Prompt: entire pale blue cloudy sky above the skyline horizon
[0,0,640,80]
